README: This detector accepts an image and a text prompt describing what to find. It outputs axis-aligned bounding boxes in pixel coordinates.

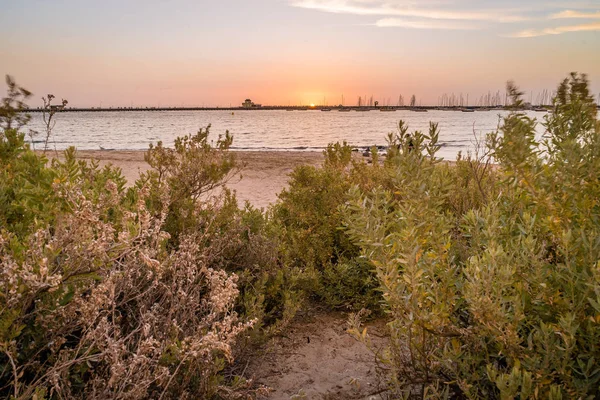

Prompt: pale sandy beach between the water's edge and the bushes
[64,150,323,208]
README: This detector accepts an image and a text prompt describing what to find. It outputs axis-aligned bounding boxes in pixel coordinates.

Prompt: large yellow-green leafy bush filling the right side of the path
[346,74,600,399]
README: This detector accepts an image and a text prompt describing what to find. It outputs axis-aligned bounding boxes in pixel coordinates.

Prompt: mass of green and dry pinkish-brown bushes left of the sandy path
[0,78,262,398]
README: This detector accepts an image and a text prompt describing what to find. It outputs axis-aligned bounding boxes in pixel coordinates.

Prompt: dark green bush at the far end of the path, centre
[272,143,381,309]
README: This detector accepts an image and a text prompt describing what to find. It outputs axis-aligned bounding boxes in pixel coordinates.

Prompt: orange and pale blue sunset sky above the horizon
[0,0,600,107]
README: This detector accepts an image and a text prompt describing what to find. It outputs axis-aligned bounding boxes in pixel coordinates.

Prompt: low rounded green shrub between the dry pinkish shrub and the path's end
[188,192,304,338]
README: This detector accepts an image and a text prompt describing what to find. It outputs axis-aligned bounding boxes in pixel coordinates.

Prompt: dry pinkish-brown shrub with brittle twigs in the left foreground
[0,182,252,398]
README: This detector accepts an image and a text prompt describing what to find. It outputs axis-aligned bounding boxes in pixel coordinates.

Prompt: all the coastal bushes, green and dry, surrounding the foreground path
[0,74,600,399]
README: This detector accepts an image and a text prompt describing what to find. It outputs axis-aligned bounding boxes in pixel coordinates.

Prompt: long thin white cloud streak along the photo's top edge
[291,0,528,22]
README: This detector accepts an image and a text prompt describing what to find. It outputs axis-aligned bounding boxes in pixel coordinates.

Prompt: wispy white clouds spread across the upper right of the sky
[288,0,600,38]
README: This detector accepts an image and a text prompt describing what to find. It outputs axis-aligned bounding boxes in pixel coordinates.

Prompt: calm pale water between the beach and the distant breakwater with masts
[30,110,545,159]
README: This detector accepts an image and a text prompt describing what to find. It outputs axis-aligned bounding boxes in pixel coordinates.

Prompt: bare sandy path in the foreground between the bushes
[248,312,384,400]
